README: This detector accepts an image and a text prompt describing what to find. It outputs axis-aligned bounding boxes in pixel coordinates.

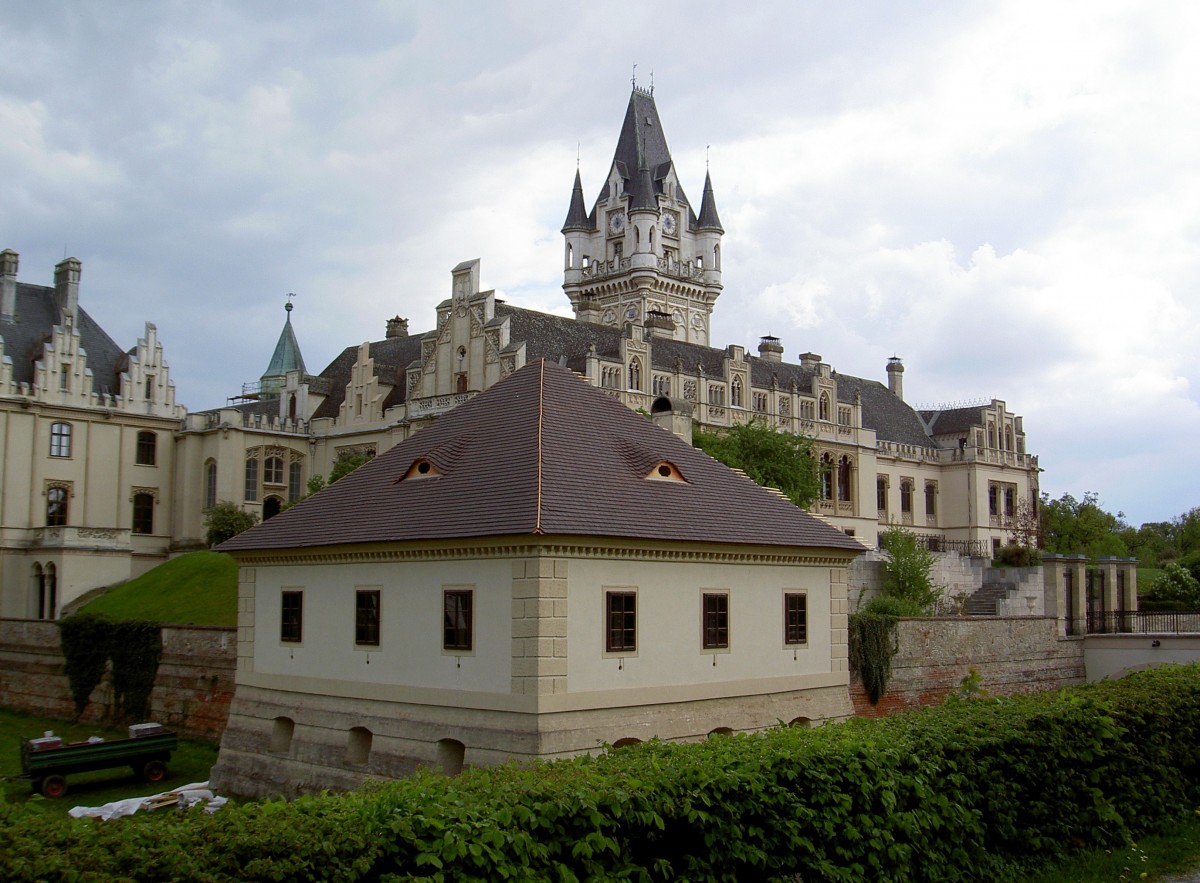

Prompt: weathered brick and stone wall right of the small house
[850,617,1086,717]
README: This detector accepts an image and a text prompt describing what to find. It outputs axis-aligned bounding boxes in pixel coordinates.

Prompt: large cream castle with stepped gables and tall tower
[0,86,1038,619]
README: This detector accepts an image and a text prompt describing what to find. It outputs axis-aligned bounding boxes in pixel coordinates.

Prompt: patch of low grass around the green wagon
[0,709,217,816]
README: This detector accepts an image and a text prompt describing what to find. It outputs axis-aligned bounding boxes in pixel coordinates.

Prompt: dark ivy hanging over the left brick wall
[59,613,162,720]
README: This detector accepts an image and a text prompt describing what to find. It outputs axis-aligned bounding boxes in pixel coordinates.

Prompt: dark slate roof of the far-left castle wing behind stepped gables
[0,282,128,396]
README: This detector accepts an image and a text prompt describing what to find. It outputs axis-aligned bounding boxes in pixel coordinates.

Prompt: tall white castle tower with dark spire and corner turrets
[563,86,725,344]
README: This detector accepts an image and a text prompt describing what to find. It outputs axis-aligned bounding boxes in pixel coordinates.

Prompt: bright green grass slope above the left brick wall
[80,552,238,626]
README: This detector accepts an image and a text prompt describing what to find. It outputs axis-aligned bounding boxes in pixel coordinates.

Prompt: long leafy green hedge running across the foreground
[0,666,1200,881]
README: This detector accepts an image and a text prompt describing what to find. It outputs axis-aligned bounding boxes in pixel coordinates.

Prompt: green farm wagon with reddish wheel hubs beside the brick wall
[20,725,179,798]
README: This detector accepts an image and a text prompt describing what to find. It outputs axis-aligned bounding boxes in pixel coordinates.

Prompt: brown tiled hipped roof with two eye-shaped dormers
[221,360,862,552]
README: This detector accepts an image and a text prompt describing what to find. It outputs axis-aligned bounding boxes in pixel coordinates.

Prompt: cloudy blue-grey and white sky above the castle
[0,0,1200,524]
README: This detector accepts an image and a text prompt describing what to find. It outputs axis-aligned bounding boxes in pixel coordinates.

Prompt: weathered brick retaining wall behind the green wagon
[0,619,236,743]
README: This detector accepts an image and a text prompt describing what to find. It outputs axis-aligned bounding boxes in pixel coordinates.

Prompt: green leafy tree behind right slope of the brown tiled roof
[692,420,821,509]
